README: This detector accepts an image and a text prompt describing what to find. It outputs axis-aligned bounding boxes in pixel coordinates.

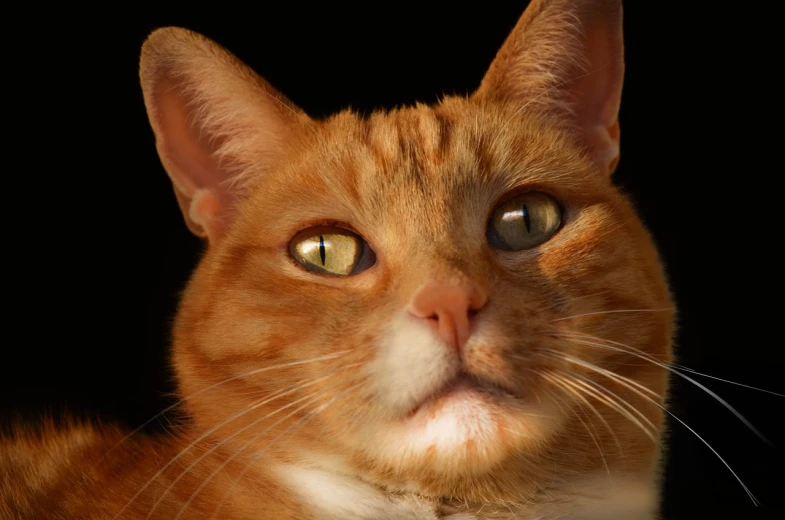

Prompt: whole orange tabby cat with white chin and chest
[0,0,675,520]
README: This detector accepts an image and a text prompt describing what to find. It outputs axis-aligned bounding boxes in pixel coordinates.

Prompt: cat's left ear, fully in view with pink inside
[139,27,307,242]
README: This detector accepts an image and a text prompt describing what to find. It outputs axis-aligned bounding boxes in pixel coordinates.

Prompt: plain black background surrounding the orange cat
[0,1,785,519]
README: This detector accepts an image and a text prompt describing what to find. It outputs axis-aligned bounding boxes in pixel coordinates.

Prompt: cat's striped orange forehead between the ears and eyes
[245,98,608,242]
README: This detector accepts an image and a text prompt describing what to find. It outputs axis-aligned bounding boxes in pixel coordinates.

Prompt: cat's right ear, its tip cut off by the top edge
[474,0,624,175]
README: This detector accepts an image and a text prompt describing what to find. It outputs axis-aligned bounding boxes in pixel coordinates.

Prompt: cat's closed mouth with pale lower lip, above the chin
[406,372,521,419]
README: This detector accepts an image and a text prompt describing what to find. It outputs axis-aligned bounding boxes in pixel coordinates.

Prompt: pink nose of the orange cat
[408,282,488,351]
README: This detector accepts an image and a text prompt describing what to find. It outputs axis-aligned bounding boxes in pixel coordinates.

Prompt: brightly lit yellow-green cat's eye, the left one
[289,227,376,276]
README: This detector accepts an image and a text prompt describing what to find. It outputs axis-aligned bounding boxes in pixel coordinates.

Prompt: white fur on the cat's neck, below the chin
[272,448,657,520]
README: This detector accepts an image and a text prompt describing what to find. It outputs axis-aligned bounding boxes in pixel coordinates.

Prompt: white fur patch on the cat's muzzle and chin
[361,314,550,472]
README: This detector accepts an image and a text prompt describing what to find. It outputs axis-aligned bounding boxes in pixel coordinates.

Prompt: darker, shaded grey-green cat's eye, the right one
[488,191,562,251]
